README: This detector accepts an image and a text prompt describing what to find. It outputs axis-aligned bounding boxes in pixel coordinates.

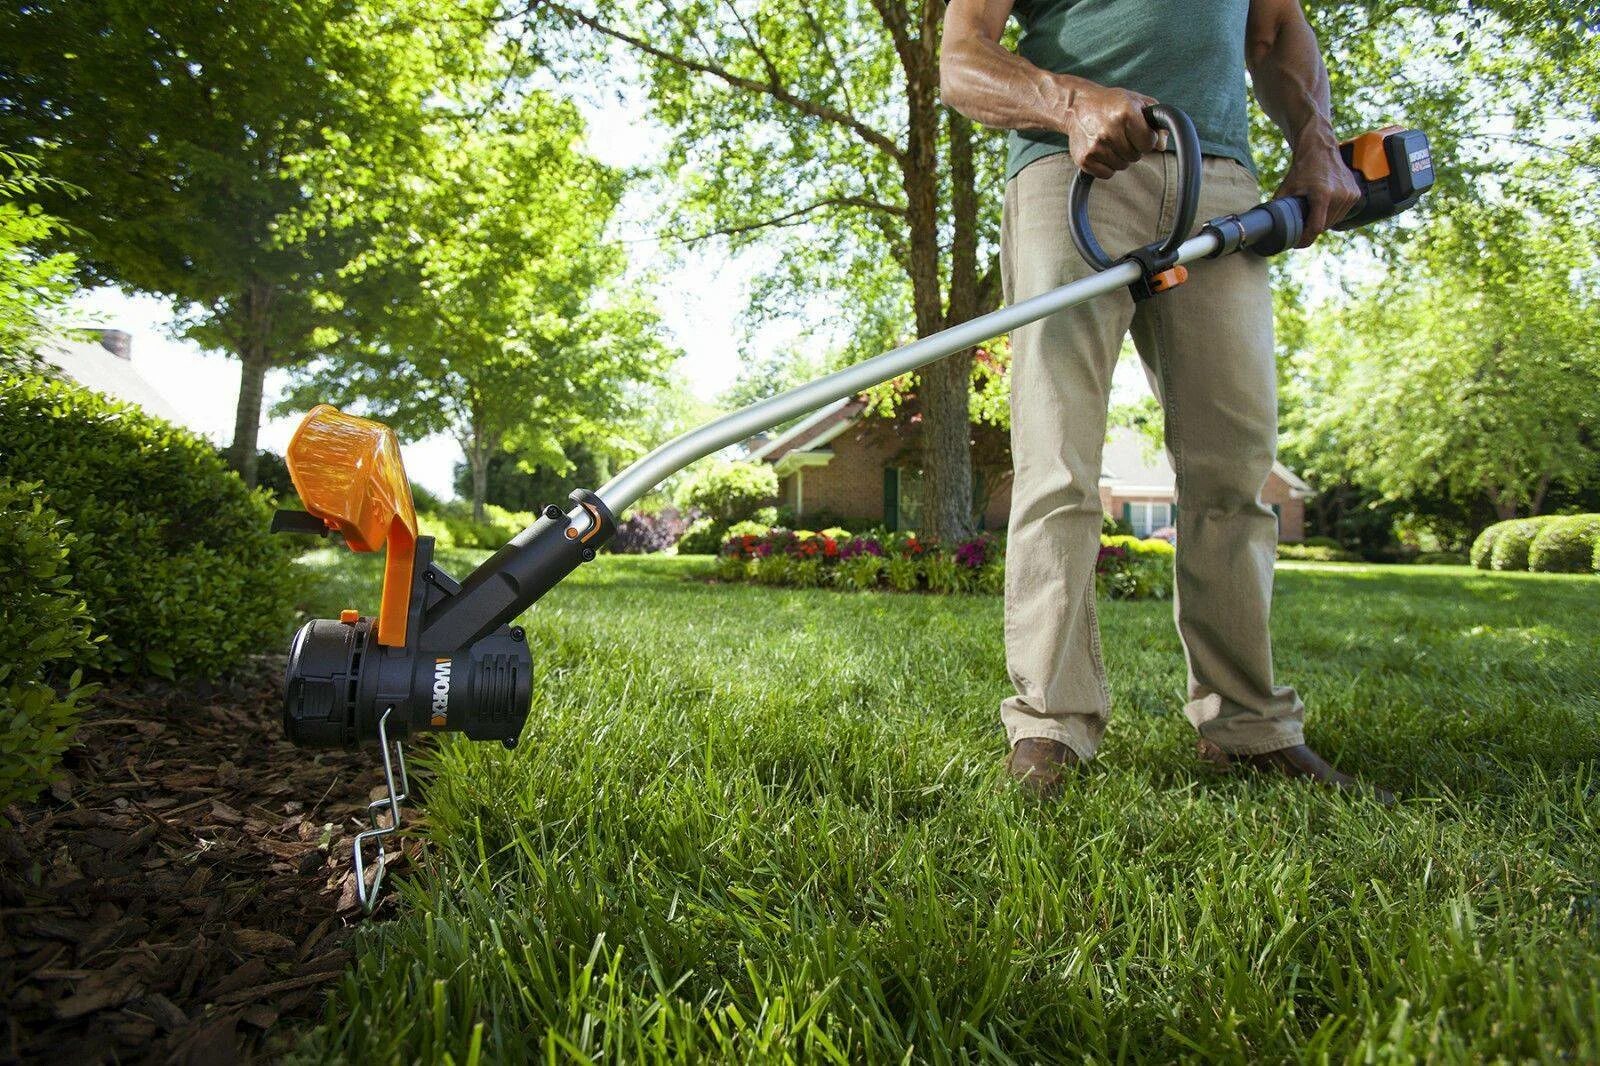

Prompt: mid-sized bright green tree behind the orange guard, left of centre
[283,93,672,520]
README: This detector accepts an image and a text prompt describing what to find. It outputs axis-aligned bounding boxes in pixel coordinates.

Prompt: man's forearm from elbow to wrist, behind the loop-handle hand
[939,37,1083,133]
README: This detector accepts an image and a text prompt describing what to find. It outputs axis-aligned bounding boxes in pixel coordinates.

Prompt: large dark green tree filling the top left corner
[0,0,485,482]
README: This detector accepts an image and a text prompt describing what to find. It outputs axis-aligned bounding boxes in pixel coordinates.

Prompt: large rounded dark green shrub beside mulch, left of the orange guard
[0,375,296,677]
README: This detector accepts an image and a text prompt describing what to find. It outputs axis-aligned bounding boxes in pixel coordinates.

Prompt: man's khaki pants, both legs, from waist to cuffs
[1000,152,1304,759]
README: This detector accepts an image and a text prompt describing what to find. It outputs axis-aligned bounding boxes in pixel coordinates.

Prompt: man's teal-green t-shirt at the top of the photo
[1006,0,1256,178]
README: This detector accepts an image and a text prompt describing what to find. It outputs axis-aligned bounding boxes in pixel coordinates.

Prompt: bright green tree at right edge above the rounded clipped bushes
[1290,206,1600,519]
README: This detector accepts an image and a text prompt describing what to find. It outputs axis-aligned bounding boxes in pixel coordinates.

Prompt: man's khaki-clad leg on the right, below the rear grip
[1132,158,1304,755]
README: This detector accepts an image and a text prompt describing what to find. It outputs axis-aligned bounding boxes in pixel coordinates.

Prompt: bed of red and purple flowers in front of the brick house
[717,523,1173,599]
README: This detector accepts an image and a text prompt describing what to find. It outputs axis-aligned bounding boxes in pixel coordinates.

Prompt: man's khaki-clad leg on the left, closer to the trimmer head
[1000,155,1165,771]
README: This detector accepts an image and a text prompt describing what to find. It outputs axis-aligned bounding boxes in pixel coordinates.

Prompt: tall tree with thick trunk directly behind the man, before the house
[530,0,1002,536]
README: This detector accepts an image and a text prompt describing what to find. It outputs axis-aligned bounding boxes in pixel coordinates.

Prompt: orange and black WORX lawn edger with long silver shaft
[274,104,1434,908]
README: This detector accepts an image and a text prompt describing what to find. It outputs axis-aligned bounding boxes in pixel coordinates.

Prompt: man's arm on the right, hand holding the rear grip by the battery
[1245,0,1362,248]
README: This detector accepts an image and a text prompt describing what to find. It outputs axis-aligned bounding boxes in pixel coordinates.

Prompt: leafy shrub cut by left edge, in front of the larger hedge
[0,480,94,809]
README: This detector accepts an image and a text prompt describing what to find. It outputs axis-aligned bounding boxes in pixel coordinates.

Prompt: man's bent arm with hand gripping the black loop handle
[939,0,1162,178]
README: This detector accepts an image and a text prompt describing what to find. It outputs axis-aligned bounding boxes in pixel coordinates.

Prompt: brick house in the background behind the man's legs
[749,399,1312,543]
